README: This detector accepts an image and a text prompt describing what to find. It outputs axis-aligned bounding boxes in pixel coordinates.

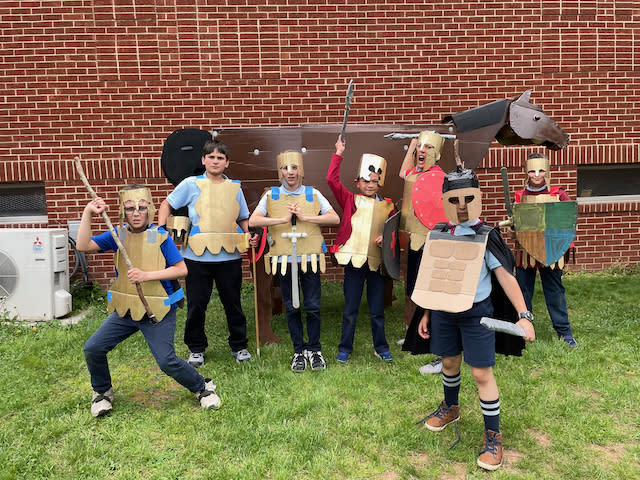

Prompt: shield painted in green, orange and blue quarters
[513,201,578,266]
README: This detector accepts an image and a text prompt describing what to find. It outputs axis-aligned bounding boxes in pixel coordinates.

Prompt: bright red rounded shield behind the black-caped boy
[411,168,447,230]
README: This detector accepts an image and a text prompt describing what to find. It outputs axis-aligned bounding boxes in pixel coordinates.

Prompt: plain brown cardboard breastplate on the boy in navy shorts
[411,229,488,313]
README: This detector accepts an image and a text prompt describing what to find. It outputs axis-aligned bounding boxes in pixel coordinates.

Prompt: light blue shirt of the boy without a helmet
[167,174,249,262]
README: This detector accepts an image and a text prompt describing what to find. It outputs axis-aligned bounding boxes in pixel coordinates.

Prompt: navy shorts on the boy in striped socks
[429,297,496,368]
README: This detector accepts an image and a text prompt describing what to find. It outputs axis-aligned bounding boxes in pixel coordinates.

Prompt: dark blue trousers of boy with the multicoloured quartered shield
[516,267,571,337]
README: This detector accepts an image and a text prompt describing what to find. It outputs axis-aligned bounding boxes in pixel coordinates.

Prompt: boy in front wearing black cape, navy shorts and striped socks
[413,170,535,470]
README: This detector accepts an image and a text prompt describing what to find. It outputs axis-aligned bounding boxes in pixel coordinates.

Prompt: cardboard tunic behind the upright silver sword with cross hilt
[264,187,326,275]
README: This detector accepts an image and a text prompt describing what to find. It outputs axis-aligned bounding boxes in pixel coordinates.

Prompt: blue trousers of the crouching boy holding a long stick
[84,308,204,393]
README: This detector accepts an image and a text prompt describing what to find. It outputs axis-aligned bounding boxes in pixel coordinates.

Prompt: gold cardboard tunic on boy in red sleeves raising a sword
[334,195,393,271]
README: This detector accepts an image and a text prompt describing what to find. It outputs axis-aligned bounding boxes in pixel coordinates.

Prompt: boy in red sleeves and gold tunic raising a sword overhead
[327,136,393,363]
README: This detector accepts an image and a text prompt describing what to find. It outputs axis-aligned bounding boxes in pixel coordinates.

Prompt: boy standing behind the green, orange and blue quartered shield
[515,153,578,348]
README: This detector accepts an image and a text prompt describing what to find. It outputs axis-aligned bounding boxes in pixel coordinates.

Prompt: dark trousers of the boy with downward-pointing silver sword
[278,265,321,353]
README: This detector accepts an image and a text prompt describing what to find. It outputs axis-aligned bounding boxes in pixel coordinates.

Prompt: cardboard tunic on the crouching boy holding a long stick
[107,227,171,321]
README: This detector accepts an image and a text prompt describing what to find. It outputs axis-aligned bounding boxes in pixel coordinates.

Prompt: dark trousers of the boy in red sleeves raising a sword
[338,263,389,353]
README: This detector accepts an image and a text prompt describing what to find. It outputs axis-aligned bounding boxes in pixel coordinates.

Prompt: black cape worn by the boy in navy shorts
[402,222,525,357]
